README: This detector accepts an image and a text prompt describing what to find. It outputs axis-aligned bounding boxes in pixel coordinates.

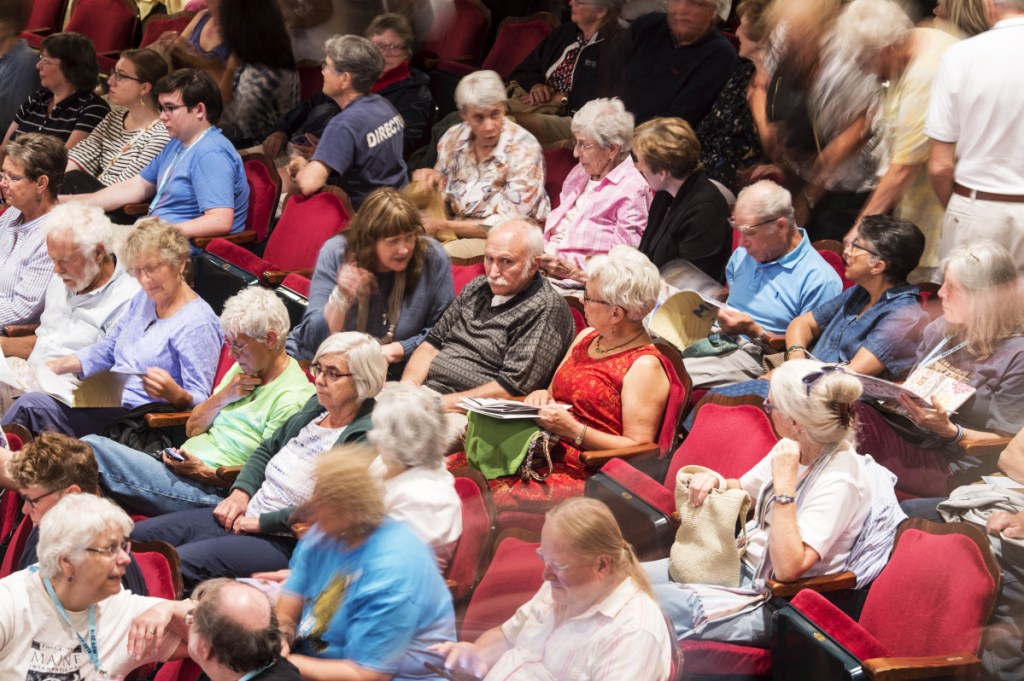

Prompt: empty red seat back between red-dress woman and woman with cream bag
[665,405,778,491]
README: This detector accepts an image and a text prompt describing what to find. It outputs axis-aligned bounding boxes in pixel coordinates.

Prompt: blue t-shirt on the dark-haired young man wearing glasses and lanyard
[139,128,249,233]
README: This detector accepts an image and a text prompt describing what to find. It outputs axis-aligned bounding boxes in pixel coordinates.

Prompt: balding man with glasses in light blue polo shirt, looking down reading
[684,180,843,387]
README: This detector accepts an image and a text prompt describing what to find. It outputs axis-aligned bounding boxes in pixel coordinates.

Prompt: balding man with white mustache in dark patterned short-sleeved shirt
[401,219,574,412]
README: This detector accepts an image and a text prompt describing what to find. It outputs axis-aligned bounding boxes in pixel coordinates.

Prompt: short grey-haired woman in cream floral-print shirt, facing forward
[413,71,551,257]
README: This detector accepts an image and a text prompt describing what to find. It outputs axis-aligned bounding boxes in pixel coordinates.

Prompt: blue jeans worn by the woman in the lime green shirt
[82,435,227,516]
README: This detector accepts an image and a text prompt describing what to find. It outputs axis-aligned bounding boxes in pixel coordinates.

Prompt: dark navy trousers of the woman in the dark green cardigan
[131,508,296,590]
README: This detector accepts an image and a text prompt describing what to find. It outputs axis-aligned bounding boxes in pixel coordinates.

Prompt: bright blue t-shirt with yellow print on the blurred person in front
[285,519,456,681]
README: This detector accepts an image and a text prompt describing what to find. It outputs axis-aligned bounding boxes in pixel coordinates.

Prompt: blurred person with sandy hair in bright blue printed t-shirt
[276,448,455,679]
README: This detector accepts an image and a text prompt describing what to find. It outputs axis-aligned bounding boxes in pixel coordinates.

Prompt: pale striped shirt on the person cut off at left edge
[0,207,53,324]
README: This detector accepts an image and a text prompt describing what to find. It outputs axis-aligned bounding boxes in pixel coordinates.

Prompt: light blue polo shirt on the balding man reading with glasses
[725,229,843,334]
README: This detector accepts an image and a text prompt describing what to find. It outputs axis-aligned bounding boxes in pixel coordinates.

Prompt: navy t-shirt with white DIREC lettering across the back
[312,94,406,209]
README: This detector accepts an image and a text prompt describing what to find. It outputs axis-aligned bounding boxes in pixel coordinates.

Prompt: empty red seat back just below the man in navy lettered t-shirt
[263,193,350,270]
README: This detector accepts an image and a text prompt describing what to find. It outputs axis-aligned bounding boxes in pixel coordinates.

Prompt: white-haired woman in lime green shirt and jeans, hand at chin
[84,287,314,516]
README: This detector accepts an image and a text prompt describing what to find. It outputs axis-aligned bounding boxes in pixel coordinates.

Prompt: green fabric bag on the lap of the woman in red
[465,412,543,480]
